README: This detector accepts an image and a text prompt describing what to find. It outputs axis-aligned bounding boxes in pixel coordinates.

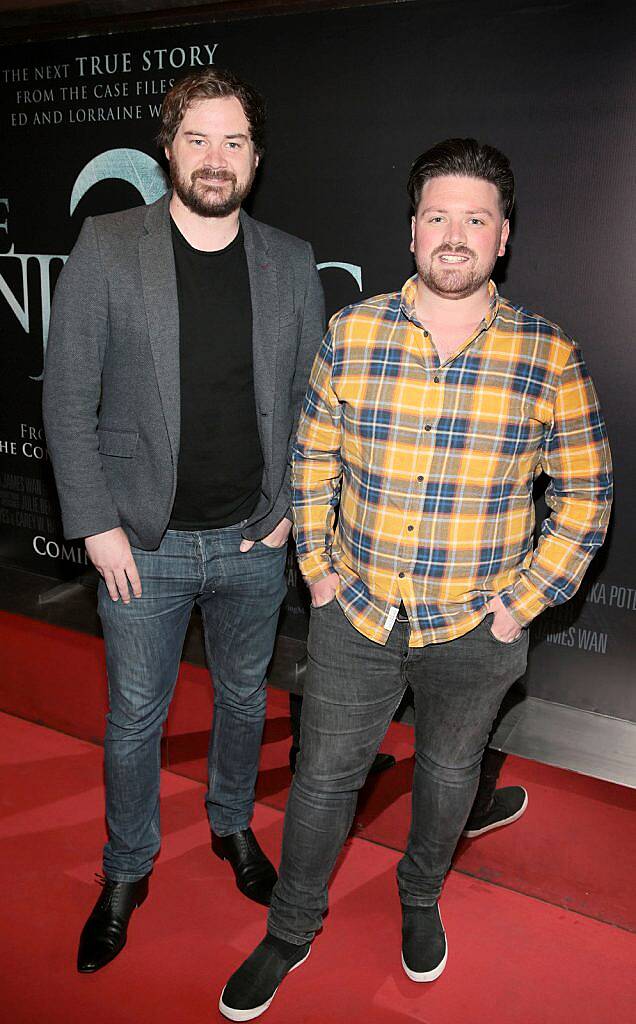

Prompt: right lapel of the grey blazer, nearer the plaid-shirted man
[241,210,279,465]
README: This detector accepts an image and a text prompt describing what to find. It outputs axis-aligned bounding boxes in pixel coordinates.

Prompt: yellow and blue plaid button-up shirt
[292,278,611,647]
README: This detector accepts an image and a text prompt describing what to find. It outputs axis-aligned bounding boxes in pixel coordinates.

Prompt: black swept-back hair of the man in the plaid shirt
[407,138,514,217]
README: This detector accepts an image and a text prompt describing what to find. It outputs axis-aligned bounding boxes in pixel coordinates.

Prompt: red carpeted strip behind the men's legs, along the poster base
[0,612,636,933]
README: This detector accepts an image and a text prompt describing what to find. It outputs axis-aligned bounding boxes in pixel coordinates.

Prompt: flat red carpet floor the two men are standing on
[0,715,636,1024]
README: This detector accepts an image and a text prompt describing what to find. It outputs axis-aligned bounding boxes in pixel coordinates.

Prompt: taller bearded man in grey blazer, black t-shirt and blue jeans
[44,69,324,972]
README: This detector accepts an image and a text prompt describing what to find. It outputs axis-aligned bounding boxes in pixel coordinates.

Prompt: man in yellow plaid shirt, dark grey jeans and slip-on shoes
[220,139,611,1020]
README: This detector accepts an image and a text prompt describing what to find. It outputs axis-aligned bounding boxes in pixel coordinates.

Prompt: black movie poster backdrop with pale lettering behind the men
[0,0,636,721]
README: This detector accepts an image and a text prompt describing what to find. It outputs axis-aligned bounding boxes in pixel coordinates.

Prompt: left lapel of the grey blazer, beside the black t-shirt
[139,193,181,466]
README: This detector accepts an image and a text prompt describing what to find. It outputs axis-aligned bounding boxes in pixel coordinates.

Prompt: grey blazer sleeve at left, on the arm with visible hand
[42,217,120,538]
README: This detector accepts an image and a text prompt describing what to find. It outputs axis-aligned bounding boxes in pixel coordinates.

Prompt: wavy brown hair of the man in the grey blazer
[157,68,265,157]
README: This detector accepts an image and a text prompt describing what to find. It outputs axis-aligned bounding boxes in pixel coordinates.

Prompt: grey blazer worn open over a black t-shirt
[43,195,325,549]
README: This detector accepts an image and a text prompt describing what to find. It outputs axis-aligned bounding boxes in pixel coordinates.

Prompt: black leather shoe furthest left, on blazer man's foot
[77,874,150,974]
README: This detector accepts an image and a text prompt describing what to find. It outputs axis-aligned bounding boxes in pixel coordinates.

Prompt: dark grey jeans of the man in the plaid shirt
[267,601,527,944]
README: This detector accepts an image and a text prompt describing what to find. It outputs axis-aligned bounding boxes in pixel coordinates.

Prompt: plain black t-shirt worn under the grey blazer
[169,221,263,529]
